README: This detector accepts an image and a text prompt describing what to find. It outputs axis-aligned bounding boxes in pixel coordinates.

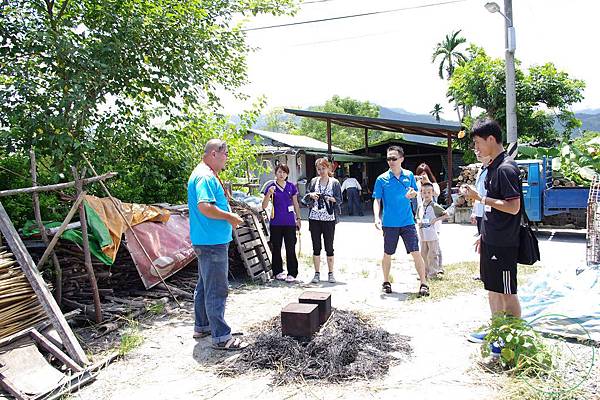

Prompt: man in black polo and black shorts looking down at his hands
[461,119,521,324]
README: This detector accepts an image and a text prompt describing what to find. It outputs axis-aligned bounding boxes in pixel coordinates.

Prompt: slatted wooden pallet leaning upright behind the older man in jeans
[233,212,273,282]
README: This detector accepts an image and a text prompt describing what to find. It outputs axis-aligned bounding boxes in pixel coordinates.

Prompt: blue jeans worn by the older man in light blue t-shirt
[194,243,231,343]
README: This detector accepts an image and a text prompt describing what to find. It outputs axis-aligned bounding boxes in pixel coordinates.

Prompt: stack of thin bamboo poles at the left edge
[0,247,46,339]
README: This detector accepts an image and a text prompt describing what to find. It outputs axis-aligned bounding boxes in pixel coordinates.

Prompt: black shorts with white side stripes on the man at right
[479,242,518,294]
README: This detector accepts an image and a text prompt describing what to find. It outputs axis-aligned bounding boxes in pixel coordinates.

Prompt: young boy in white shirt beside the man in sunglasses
[417,183,448,278]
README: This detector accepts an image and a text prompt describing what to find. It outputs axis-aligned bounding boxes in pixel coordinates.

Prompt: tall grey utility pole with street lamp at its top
[485,0,517,158]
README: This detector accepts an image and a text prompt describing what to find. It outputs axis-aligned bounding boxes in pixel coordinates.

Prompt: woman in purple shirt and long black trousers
[262,164,301,282]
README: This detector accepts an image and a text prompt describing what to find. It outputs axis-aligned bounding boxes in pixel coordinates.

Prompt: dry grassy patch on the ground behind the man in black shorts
[408,261,539,301]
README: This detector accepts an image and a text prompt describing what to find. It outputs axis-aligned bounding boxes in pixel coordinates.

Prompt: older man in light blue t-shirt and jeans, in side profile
[188,139,248,350]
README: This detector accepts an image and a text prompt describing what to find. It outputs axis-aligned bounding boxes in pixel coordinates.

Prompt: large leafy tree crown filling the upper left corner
[0,0,293,169]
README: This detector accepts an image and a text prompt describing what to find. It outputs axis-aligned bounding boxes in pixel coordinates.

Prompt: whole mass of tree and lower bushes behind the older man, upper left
[0,0,295,220]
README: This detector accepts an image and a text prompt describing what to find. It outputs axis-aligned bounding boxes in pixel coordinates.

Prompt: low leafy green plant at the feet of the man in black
[481,314,553,376]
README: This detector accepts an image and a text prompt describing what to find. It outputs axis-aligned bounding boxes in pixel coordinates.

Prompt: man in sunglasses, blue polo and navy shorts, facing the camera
[373,146,429,296]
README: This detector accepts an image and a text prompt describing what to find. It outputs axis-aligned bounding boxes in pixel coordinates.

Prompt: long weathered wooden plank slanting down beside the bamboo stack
[0,202,89,365]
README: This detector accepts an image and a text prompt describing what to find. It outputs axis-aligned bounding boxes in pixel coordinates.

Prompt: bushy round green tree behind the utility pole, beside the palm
[448,45,585,143]
